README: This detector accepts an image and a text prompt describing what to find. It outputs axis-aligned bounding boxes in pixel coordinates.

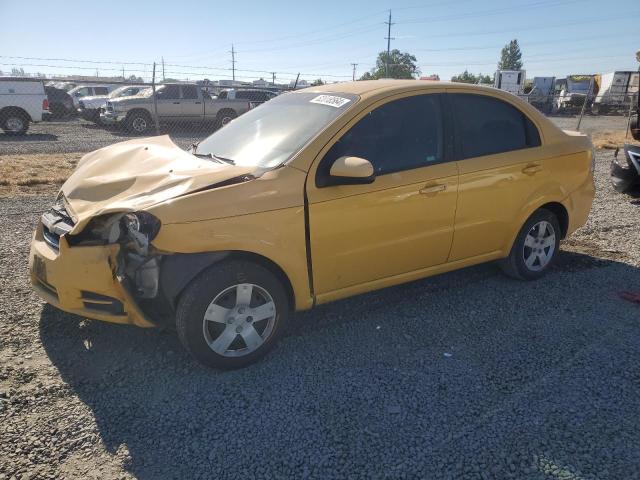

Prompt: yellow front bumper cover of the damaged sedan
[29,223,155,327]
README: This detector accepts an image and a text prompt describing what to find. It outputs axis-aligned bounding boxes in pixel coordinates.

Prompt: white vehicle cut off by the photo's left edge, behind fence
[0,77,49,135]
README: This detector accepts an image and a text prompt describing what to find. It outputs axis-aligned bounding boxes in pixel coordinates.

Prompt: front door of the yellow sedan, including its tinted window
[307,93,458,302]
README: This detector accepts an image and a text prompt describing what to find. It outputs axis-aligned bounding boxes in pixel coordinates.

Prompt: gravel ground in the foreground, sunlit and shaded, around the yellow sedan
[0,153,640,479]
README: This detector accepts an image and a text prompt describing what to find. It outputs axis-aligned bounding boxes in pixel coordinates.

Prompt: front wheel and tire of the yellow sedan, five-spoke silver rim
[176,260,290,369]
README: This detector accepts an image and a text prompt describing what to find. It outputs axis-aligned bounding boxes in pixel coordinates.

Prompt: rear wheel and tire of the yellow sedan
[500,208,561,280]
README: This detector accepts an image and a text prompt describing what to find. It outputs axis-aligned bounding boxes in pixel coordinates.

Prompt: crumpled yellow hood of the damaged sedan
[61,135,254,233]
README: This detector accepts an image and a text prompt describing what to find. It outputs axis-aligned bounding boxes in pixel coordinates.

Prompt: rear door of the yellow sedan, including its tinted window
[447,92,549,261]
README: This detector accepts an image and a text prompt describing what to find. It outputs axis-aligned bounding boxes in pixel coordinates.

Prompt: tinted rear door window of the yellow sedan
[451,93,540,158]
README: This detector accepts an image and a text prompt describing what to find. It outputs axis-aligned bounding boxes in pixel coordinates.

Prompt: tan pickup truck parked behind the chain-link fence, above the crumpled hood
[100,83,253,135]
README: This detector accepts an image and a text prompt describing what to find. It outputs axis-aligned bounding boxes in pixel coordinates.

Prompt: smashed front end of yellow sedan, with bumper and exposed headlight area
[30,196,165,327]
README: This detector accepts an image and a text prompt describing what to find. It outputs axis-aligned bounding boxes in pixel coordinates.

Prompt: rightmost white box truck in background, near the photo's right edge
[591,71,640,115]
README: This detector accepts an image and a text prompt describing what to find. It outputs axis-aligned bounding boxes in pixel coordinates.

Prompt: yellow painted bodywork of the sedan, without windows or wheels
[30,80,594,326]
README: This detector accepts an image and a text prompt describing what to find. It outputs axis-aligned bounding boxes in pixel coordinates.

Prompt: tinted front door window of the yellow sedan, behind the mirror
[318,94,444,178]
